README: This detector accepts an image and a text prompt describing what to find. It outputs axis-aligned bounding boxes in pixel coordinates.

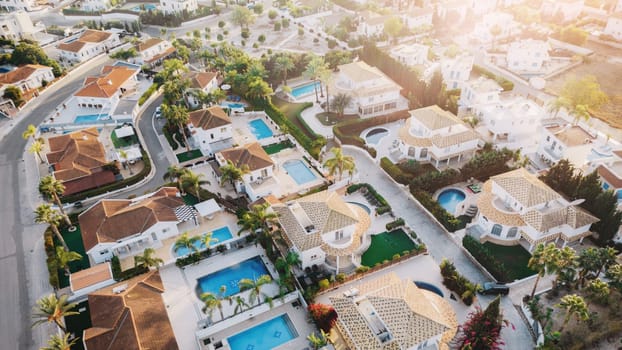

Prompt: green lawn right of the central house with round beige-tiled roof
[361,229,416,267]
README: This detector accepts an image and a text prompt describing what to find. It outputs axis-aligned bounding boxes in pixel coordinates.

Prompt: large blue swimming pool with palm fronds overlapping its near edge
[197,256,270,297]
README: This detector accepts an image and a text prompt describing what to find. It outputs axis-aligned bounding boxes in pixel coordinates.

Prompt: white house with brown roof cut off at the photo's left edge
[0,64,54,96]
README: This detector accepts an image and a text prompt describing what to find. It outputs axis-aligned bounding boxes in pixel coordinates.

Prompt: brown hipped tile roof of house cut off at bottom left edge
[81,271,179,350]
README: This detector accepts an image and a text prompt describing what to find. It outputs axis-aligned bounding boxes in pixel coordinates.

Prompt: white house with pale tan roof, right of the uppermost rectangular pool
[330,61,406,118]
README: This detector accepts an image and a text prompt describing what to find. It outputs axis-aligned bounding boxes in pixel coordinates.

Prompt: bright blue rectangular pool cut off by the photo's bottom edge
[227,314,298,350]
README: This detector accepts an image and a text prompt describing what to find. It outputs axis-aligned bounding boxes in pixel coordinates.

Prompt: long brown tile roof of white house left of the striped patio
[78,187,185,252]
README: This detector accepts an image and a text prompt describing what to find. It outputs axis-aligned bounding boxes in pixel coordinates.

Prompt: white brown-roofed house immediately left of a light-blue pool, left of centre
[214,142,278,201]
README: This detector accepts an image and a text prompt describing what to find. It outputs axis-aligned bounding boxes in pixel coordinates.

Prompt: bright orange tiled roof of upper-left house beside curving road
[74,66,138,98]
